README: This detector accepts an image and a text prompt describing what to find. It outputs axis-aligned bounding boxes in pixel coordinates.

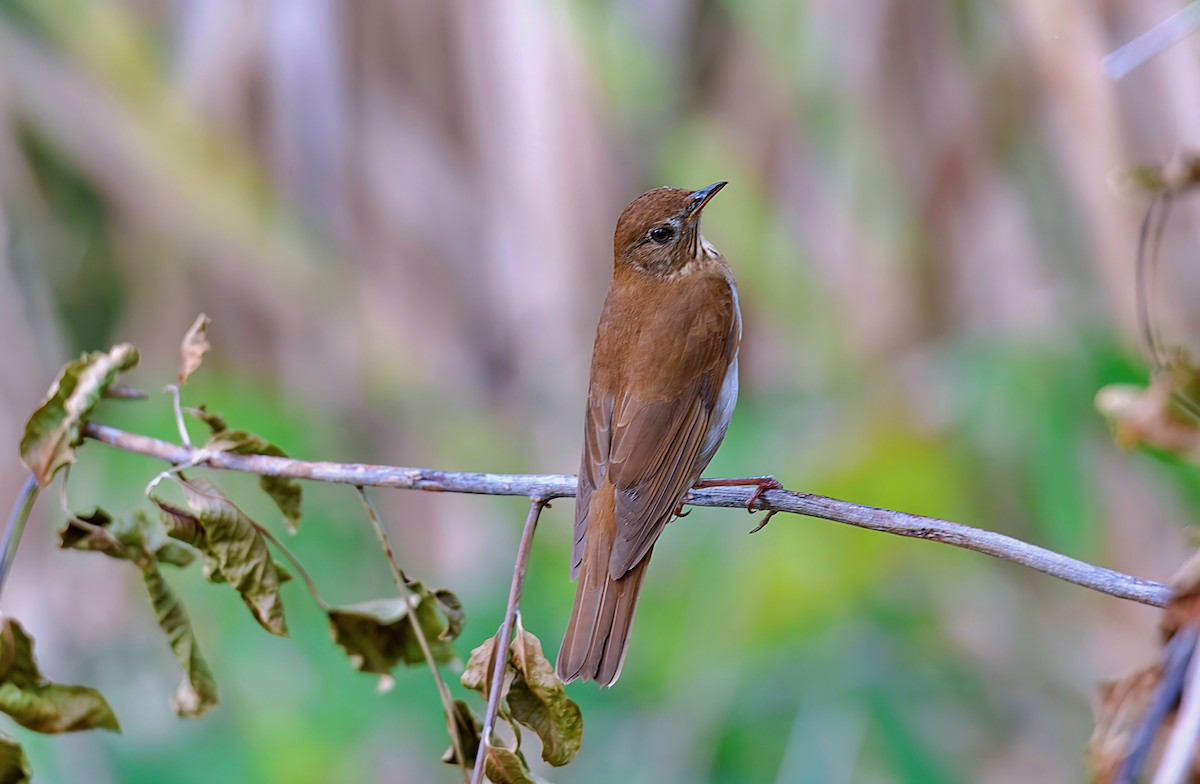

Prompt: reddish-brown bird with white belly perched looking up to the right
[557,182,779,686]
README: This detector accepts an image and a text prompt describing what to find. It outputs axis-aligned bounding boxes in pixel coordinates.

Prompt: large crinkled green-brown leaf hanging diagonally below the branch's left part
[151,479,288,636]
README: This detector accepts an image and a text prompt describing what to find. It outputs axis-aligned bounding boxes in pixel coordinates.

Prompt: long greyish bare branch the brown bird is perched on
[84,423,1171,608]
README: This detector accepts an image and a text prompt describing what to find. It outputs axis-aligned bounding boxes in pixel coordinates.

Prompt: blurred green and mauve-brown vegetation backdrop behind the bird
[0,0,1200,784]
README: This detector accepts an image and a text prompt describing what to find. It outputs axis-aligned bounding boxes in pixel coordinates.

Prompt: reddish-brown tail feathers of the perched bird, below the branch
[557,535,653,686]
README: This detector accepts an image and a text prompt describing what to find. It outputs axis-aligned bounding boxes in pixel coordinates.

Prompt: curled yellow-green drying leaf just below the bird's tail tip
[508,623,583,766]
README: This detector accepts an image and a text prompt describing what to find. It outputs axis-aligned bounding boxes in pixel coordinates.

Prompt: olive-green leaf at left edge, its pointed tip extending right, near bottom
[0,618,121,732]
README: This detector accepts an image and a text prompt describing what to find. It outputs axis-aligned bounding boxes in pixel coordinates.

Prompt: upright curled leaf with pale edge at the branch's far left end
[20,343,138,487]
